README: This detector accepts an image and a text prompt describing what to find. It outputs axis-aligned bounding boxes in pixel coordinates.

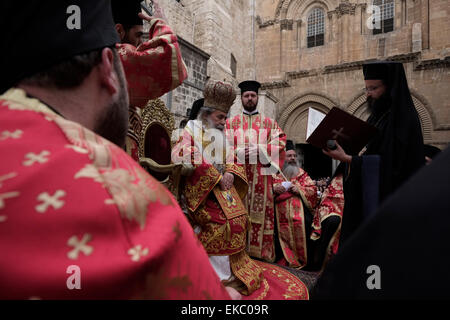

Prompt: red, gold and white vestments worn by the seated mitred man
[172,121,308,300]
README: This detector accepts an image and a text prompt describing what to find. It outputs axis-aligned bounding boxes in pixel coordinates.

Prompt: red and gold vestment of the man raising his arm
[116,18,187,161]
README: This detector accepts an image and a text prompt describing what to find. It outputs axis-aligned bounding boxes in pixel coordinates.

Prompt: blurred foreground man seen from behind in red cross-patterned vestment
[0,0,230,299]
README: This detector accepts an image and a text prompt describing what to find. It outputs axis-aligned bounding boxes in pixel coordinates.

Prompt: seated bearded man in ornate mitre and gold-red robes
[172,81,308,299]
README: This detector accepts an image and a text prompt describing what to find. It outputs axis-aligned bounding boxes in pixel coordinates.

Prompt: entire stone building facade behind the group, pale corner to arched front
[154,0,450,175]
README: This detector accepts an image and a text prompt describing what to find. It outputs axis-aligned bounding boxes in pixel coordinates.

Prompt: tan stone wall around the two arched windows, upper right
[256,0,450,148]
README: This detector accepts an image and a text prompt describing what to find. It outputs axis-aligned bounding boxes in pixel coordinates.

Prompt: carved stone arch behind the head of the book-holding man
[347,92,435,143]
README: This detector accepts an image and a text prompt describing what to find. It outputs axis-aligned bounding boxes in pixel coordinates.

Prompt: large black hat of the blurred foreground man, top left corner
[0,0,120,93]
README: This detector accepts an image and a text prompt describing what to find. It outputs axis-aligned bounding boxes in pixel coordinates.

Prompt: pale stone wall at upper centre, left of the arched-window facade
[159,0,255,125]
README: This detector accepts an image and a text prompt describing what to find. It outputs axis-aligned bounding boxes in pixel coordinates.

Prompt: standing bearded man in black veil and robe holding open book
[324,62,424,243]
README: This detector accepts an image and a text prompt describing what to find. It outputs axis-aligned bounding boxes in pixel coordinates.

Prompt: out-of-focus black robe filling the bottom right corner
[311,148,450,300]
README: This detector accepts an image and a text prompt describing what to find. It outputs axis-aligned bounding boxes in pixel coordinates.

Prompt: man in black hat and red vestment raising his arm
[112,0,187,162]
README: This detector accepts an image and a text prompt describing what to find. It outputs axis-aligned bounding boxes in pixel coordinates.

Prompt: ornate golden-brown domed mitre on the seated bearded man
[203,80,236,113]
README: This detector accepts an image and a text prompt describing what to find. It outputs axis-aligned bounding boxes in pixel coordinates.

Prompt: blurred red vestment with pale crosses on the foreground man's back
[0,89,229,300]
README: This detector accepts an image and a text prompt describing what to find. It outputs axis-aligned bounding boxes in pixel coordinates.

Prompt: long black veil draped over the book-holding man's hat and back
[363,61,425,197]
